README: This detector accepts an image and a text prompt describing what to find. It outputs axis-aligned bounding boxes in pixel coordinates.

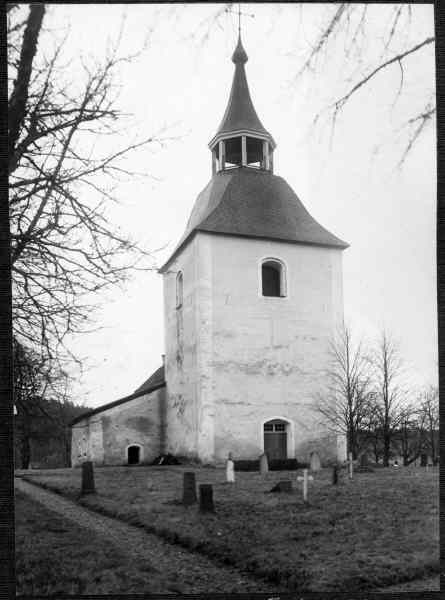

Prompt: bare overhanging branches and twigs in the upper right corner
[288,2,436,166]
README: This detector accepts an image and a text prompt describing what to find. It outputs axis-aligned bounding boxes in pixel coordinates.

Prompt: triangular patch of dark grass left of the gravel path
[15,492,179,596]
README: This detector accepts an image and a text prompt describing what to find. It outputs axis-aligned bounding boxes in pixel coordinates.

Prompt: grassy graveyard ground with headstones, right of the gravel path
[16,466,439,593]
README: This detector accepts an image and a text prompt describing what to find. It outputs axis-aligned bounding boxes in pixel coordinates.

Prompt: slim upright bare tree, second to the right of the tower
[371,331,406,467]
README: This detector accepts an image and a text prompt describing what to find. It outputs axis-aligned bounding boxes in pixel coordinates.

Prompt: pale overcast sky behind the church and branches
[36,3,437,406]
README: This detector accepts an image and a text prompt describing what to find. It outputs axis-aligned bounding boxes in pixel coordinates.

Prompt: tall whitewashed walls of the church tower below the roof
[164,232,343,462]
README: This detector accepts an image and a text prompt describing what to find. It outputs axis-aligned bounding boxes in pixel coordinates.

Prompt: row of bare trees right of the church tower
[315,325,439,466]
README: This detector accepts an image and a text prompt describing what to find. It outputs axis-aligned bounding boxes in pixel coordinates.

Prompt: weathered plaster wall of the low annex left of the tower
[71,388,165,467]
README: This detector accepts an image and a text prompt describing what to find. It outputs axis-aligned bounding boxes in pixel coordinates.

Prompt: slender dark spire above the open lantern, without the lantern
[209,31,275,147]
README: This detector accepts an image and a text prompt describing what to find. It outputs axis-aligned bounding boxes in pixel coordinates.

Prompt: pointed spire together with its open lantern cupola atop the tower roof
[209,35,276,173]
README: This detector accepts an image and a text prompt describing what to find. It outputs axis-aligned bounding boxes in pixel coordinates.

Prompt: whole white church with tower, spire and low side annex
[72,37,348,466]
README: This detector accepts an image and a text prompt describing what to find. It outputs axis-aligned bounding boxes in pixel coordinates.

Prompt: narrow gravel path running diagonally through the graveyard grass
[15,478,277,594]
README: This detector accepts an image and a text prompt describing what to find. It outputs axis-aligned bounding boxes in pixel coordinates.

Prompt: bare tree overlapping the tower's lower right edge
[315,324,371,458]
